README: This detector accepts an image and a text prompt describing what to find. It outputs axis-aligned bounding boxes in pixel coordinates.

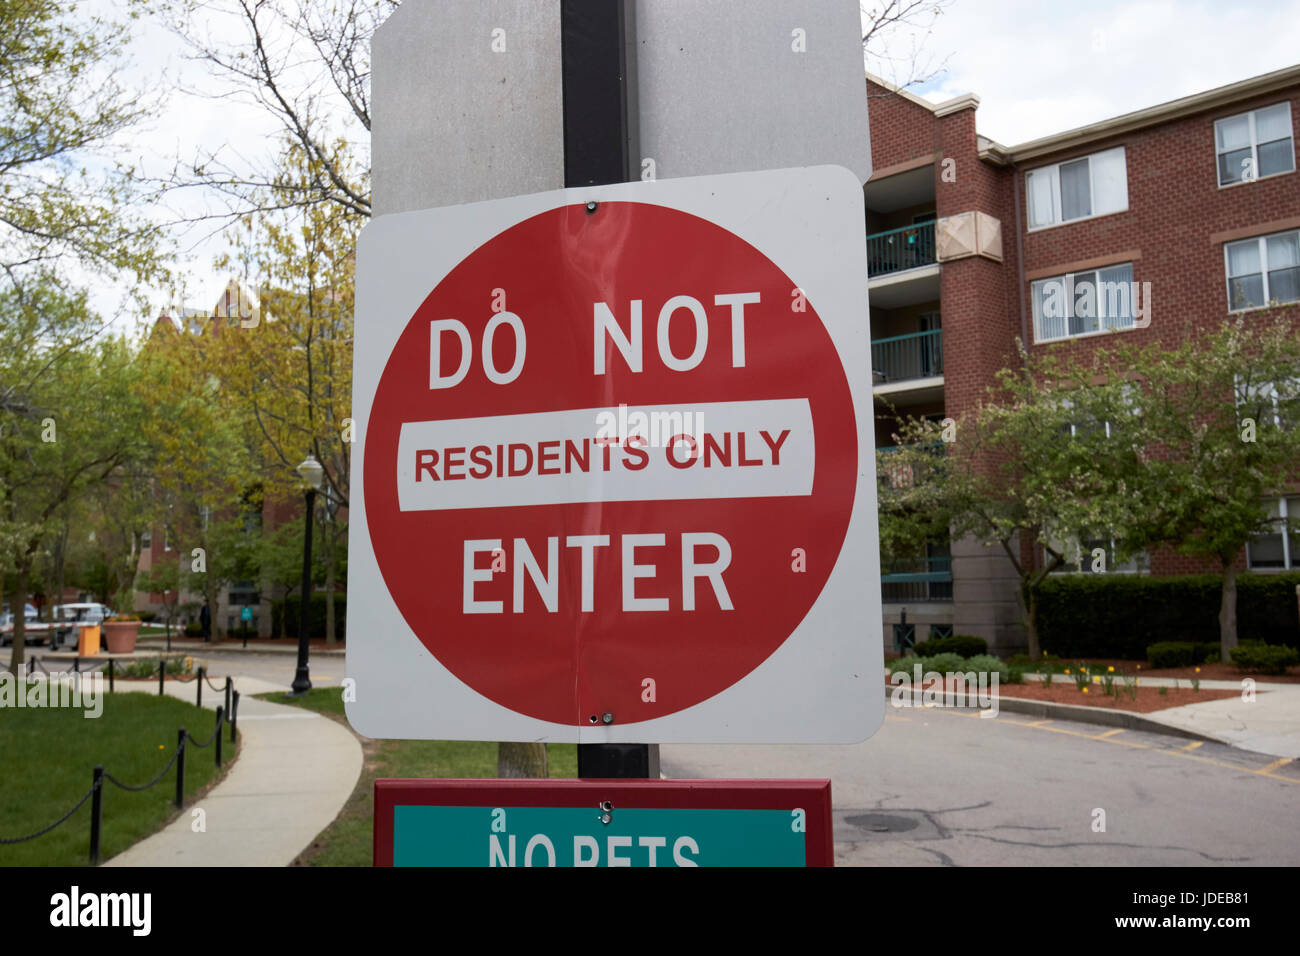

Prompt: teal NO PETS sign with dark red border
[374,780,835,868]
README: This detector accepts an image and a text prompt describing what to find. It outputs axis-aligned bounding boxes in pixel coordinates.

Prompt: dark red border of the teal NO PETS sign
[373,779,835,866]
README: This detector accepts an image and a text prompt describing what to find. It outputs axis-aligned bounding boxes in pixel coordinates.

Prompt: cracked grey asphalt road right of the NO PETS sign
[660,709,1300,868]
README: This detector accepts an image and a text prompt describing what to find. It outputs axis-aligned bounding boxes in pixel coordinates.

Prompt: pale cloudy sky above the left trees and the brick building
[79,0,1300,328]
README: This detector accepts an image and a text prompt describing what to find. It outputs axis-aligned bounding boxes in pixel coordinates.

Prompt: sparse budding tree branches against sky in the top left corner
[0,0,161,290]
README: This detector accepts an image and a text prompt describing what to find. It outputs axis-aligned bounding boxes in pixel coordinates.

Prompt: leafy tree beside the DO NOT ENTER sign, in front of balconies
[878,340,1147,659]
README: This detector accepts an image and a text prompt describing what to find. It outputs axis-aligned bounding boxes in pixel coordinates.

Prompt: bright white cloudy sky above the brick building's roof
[899,0,1300,146]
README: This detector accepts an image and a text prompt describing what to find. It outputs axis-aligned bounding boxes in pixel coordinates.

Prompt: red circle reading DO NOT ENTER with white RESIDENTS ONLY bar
[350,168,875,736]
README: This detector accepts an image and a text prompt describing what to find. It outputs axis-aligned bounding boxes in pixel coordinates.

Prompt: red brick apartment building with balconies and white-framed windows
[865,66,1300,649]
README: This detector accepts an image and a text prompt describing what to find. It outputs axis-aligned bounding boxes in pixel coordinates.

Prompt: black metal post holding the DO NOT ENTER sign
[560,0,659,778]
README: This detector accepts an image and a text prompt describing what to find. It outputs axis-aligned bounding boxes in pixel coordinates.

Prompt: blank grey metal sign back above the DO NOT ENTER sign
[371,0,871,216]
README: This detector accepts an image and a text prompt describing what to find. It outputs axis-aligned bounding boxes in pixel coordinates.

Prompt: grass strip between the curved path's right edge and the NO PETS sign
[259,687,577,866]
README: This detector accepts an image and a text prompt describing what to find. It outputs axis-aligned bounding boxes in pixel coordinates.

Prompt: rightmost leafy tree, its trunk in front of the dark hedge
[1097,316,1300,661]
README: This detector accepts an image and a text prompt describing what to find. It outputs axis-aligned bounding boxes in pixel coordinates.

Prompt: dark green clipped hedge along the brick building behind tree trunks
[1037,572,1300,661]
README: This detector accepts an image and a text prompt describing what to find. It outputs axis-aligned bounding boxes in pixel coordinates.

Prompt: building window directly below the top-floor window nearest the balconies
[1031,263,1138,342]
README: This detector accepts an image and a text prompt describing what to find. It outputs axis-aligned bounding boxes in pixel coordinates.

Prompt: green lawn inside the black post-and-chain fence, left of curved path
[0,685,235,866]
